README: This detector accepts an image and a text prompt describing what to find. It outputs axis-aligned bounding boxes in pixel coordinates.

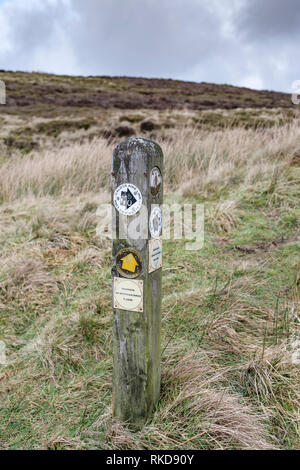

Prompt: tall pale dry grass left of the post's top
[0,139,111,202]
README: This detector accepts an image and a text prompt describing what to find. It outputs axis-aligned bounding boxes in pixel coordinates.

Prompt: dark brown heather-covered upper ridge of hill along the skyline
[0,72,292,111]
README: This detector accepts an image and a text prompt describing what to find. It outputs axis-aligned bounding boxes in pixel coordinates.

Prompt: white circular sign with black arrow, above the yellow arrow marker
[114,183,143,215]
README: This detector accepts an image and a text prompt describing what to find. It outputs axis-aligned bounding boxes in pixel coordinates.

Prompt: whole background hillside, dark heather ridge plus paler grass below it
[0,72,299,160]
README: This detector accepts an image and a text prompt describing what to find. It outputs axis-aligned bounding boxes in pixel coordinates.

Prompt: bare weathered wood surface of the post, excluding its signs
[112,138,163,427]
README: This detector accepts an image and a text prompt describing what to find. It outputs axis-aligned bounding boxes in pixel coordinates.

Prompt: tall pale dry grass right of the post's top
[163,121,300,195]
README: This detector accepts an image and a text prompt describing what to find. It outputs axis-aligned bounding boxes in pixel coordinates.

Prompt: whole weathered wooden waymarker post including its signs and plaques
[112,138,163,427]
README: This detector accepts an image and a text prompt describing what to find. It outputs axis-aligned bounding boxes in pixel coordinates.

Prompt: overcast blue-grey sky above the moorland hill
[0,0,300,92]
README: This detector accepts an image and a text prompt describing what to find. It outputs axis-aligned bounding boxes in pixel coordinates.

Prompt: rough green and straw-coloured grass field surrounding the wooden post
[0,72,300,449]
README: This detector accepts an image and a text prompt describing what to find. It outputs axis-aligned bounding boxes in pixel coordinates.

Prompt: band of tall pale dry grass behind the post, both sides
[0,120,300,202]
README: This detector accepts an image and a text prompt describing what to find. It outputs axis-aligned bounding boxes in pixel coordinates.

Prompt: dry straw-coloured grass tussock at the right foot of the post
[99,347,276,449]
